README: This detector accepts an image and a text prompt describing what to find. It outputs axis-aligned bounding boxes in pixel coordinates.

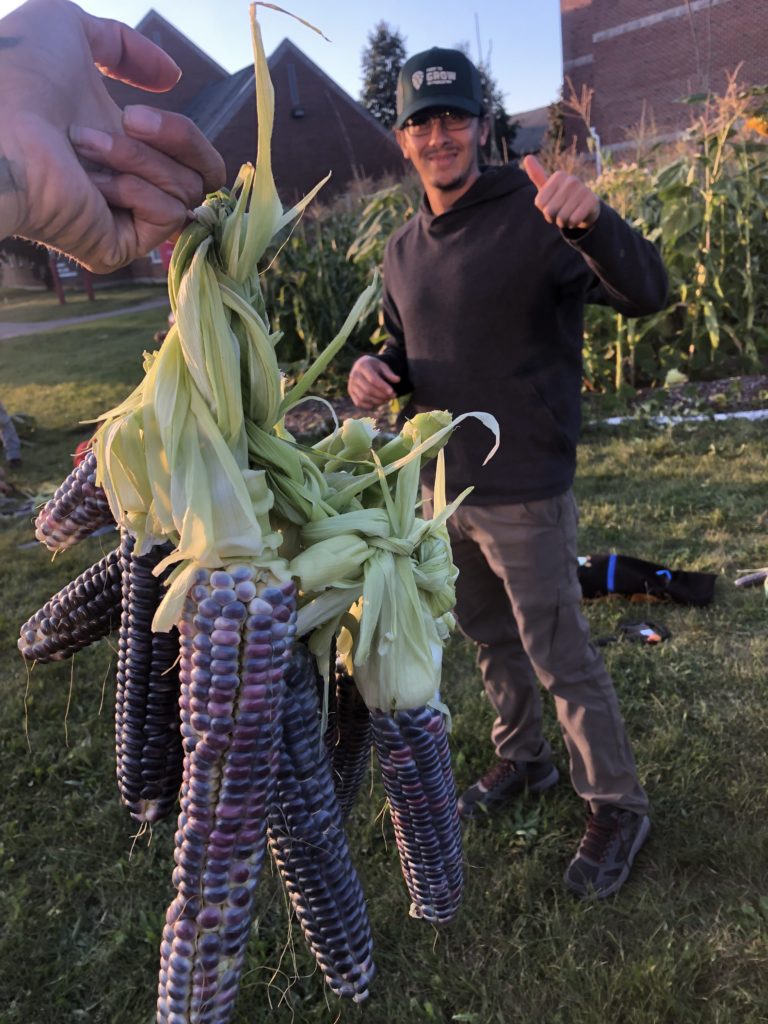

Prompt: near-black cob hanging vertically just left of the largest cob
[115,532,182,821]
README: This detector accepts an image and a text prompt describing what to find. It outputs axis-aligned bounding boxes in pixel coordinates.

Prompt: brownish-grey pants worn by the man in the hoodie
[449,492,648,813]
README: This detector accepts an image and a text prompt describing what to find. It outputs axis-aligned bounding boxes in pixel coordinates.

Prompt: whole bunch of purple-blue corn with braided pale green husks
[18,8,479,1024]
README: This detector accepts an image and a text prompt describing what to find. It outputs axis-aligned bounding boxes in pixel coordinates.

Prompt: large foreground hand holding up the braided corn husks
[0,0,225,273]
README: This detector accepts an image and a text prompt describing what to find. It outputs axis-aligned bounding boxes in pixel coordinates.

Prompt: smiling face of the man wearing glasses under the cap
[396,108,488,202]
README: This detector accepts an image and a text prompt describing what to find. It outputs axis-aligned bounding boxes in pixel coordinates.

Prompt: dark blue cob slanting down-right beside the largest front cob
[267,644,376,1002]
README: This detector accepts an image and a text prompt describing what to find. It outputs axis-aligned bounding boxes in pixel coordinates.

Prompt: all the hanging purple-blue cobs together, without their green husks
[18,452,462,1024]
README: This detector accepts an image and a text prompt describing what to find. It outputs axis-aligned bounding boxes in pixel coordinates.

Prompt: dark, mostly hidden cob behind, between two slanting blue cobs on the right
[325,665,372,818]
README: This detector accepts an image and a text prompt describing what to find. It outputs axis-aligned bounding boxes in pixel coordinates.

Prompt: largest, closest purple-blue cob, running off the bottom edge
[157,565,296,1024]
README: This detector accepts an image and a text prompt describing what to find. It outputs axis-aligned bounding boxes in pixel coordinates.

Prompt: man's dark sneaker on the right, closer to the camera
[563,807,650,899]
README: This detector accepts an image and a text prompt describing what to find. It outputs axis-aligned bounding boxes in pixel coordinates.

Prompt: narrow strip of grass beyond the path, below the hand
[0,283,167,326]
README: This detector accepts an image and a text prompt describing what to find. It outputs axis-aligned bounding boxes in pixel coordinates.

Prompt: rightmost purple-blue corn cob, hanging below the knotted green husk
[371,708,464,925]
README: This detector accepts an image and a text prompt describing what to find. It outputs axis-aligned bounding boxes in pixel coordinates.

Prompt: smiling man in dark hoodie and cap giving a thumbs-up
[349,47,667,896]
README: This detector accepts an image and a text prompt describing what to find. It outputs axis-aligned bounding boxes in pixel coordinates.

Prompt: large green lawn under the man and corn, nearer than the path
[0,311,768,1024]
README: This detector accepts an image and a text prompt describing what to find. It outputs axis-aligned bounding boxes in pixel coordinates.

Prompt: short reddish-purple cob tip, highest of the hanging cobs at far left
[35,452,115,551]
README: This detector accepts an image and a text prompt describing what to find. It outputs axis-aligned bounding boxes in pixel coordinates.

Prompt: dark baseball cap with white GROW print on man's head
[394,46,483,128]
